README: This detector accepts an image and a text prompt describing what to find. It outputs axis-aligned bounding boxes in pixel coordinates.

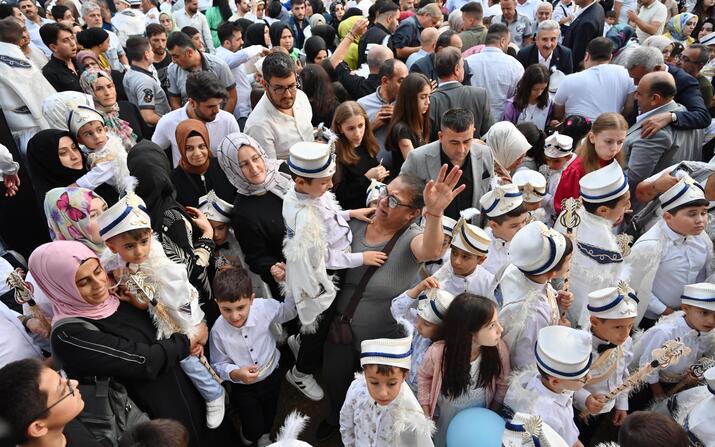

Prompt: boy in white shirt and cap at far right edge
[628,175,713,329]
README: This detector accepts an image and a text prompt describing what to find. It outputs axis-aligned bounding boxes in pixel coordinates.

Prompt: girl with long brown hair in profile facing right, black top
[385,73,432,173]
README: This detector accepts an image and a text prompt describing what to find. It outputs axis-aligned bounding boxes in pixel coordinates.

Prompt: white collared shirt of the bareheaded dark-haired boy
[209,295,298,383]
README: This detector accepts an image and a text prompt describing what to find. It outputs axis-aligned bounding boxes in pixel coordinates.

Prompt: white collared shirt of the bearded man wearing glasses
[244,89,314,160]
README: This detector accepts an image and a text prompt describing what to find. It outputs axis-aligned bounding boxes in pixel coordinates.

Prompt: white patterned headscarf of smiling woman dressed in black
[216,132,293,199]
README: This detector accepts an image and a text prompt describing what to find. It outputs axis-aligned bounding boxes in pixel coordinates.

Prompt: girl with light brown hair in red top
[554,112,628,214]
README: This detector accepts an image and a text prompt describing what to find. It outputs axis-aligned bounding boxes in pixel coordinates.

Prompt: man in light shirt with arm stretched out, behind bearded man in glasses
[216,21,268,127]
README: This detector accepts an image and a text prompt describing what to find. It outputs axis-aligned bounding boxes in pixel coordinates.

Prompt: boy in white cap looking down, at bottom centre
[340,330,434,447]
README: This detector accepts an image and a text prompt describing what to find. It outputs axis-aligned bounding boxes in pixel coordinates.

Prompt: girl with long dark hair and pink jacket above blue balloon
[417,293,511,447]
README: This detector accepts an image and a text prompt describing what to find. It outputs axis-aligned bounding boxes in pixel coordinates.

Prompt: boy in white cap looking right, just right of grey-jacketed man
[479,183,527,278]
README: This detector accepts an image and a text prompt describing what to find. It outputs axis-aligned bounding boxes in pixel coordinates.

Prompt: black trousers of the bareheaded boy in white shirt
[231,368,283,442]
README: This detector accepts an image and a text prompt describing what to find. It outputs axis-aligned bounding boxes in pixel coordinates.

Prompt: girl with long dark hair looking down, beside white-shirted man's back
[502,64,552,130]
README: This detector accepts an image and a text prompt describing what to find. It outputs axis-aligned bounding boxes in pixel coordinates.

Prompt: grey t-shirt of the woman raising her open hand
[336,219,422,351]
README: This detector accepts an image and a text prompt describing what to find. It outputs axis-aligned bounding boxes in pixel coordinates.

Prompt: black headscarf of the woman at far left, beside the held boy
[27,129,87,204]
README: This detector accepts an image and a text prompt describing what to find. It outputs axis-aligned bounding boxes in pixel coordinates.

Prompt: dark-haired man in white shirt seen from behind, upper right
[553,37,636,120]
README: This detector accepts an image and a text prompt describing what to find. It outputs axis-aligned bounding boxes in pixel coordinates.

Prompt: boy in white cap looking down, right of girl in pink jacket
[504,326,592,447]
